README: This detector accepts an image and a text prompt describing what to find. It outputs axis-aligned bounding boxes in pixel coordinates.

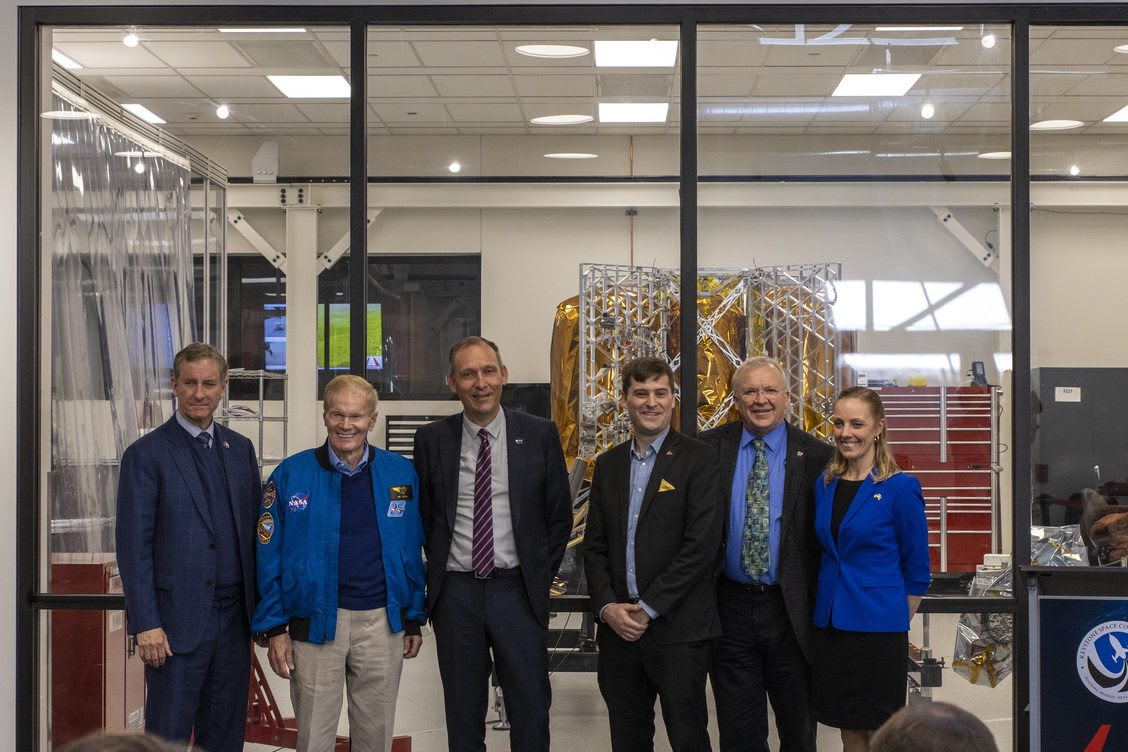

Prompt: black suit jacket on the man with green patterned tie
[700,421,831,662]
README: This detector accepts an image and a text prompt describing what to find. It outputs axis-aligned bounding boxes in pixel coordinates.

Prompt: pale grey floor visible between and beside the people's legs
[244,614,1014,752]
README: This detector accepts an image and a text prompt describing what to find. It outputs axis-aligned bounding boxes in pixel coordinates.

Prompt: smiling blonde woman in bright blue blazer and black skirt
[813,387,931,752]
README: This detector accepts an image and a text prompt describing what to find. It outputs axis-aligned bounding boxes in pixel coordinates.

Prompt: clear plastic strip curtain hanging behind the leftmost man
[44,88,194,554]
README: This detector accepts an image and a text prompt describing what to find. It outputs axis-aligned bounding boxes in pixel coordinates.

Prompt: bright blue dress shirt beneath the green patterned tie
[724,423,787,585]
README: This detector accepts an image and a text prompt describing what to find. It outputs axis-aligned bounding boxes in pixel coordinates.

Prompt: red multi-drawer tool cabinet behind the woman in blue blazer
[876,387,998,572]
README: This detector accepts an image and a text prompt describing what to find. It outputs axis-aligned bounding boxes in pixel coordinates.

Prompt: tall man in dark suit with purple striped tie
[414,337,572,752]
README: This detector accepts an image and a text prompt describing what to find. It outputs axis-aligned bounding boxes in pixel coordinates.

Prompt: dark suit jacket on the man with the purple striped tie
[414,409,572,627]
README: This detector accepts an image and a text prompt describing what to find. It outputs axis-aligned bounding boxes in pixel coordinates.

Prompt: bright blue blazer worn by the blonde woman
[814,472,931,631]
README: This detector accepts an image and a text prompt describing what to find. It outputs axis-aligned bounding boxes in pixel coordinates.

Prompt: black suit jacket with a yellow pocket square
[583,428,724,644]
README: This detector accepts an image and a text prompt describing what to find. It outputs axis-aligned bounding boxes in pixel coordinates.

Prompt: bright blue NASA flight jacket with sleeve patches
[250,444,426,644]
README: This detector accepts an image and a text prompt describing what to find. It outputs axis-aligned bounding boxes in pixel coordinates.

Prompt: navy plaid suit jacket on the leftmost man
[116,414,262,653]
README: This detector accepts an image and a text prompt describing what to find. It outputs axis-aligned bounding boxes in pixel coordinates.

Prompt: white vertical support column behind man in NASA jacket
[285,204,320,454]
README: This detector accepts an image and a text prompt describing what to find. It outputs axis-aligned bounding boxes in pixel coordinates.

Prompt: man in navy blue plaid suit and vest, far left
[117,343,262,752]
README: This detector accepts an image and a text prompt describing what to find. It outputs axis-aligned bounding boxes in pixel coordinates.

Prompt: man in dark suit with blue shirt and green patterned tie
[699,357,830,752]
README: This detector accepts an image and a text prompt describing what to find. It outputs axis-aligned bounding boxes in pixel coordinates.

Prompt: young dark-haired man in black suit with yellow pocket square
[583,357,724,752]
